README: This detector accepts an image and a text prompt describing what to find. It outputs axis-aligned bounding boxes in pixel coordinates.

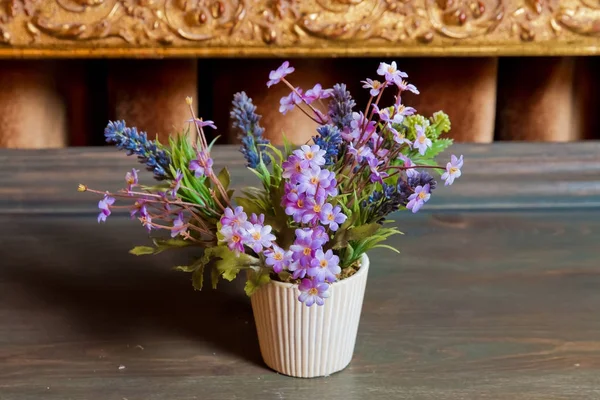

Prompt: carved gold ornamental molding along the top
[0,0,600,57]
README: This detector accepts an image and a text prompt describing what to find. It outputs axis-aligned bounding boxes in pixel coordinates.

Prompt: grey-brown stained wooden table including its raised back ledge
[0,142,600,400]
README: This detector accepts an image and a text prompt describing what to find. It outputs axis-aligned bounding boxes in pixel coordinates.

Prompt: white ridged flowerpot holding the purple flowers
[251,255,369,378]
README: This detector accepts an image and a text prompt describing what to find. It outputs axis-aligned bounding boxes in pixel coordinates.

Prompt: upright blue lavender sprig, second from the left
[229,92,271,168]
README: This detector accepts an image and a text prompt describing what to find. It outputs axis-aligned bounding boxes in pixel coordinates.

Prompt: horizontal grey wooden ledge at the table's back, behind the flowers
[0,142,600,213]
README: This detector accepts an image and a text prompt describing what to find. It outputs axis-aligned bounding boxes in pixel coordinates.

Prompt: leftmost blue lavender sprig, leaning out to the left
[104,121,171,180]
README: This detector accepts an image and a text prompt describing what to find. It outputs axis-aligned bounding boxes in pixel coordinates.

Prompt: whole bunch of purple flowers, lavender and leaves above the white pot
[79,61,463,306]
